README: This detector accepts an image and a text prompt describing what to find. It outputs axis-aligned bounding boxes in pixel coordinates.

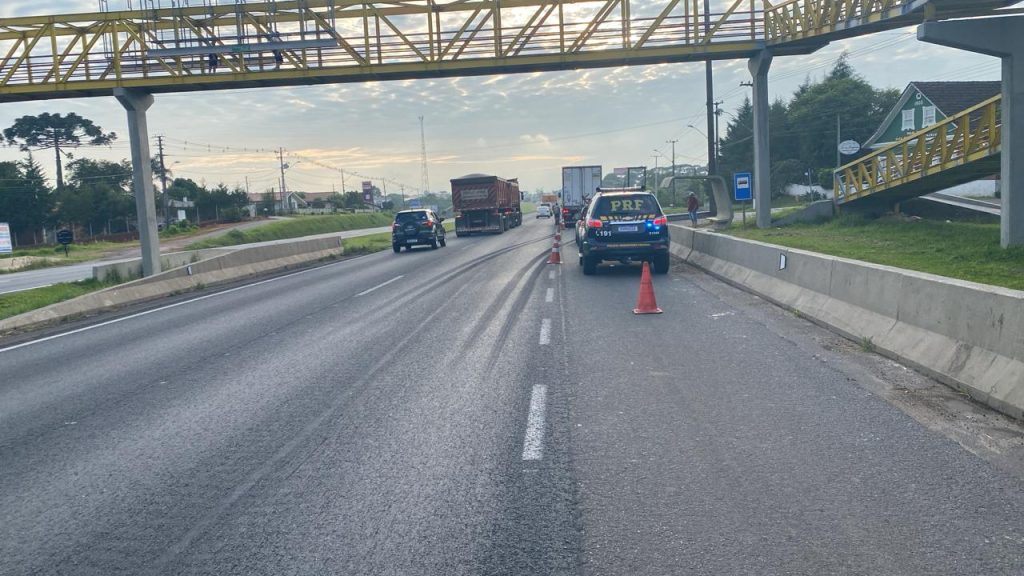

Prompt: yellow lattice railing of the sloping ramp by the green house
[835,96,1002,204]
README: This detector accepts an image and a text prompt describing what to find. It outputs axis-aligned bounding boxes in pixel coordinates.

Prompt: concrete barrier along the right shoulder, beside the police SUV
[670,224,1024,419]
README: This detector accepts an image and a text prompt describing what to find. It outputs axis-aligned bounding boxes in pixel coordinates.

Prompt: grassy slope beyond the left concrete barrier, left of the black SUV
[187,212,393,250]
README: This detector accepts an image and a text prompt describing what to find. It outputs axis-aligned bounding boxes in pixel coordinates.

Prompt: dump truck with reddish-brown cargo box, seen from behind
[452,174,522,236]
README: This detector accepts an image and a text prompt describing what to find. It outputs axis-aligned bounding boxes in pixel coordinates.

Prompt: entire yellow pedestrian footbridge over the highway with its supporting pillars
[0,0,1024,276]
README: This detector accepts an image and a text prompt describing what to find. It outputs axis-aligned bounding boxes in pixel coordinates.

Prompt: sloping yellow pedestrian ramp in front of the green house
[835,95,1002,208]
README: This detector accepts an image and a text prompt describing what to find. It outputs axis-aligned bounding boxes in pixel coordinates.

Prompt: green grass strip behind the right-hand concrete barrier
[727,215,1024,290]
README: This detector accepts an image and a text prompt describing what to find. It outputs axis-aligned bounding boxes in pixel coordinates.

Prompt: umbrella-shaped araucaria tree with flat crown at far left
[3,113,118,191]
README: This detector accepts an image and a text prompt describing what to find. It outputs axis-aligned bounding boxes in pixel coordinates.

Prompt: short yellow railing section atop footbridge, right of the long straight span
[764,0,903,43]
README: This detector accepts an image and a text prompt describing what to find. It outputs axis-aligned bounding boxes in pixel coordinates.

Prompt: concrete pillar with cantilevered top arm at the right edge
[918,16,1024,248]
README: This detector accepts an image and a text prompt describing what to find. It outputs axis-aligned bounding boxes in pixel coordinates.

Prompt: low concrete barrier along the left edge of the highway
[0,233,344,334]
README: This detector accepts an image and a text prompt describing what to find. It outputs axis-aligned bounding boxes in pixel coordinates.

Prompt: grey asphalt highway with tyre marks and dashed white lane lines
[0,219,1024,575]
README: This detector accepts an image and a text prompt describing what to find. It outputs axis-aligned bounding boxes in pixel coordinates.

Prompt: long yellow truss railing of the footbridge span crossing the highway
[0,0,764,101]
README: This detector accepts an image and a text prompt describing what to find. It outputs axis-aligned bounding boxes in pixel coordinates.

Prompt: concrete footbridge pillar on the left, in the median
[114,88,160,276]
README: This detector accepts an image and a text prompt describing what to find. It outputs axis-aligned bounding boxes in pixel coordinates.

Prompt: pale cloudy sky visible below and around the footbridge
[0,0,999,193]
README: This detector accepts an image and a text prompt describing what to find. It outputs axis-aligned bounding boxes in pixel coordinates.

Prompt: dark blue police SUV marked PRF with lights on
[577,188,670,276]
